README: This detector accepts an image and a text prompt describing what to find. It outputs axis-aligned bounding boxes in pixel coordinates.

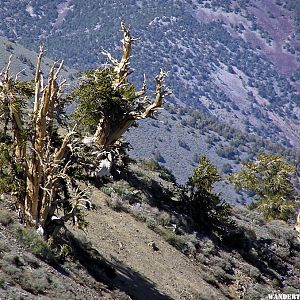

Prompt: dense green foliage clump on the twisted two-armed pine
[70,68,135,133]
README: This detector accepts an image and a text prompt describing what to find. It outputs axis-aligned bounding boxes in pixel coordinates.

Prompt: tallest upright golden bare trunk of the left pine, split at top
[25,54,69,224]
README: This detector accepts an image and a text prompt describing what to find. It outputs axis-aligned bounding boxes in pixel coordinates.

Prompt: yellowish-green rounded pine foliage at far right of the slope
[229,154,297,221]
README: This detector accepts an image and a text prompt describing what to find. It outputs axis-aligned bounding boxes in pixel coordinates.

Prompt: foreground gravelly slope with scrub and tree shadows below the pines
[0,161,300,300]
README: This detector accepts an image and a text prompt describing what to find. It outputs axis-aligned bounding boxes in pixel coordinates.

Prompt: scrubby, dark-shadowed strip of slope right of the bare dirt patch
[95,162,300,299]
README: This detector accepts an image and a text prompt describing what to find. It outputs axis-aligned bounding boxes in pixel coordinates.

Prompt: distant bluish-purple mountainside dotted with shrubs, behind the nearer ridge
[0,0,300,148]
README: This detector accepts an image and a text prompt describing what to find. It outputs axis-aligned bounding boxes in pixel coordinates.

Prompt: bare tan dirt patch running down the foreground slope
[79,190,224,300]
